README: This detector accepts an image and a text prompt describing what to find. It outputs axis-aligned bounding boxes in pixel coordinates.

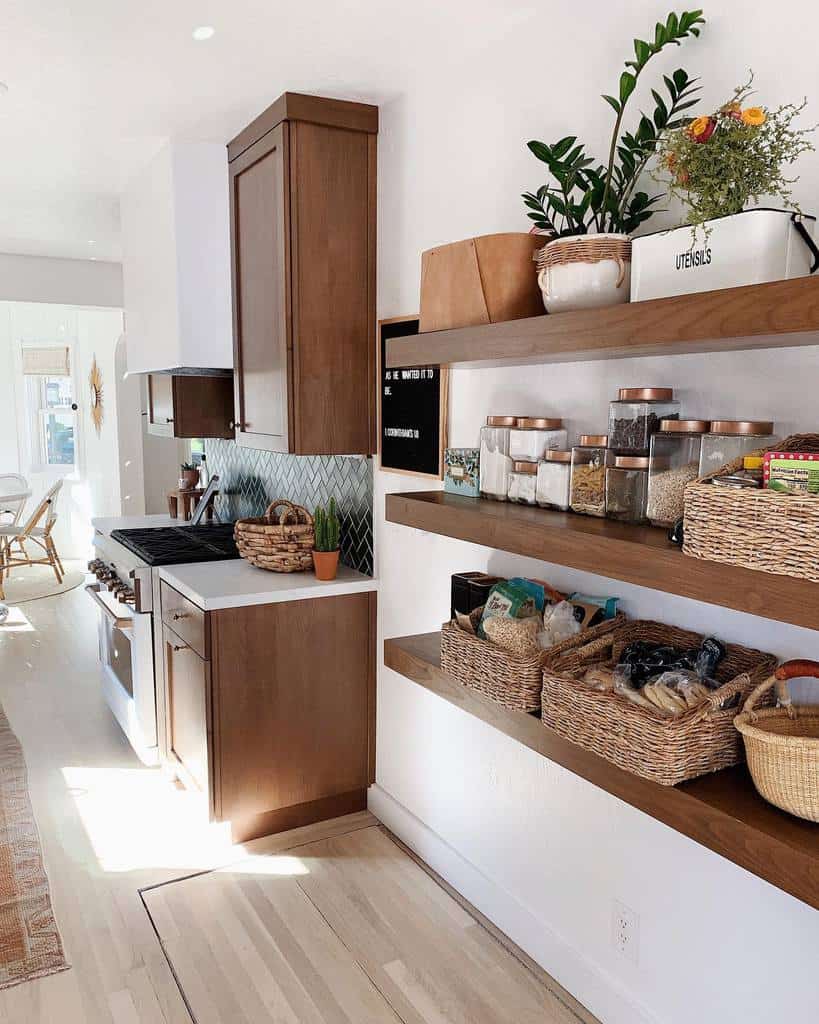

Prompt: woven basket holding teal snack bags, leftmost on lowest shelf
[441,613,624,712]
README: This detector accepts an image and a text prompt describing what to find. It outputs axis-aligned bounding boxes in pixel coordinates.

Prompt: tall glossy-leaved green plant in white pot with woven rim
[523,10,705,312]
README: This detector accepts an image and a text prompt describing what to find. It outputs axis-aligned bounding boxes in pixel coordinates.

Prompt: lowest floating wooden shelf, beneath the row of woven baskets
[384,633,819,909]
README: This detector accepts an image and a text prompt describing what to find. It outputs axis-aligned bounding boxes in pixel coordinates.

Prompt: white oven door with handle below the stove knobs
[85,584,159,765]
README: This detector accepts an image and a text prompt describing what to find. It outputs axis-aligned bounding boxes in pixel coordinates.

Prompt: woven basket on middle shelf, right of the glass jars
[683,434,819,583]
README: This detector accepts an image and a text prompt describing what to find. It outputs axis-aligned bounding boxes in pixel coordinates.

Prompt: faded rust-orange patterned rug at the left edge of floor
[0,709,70,989]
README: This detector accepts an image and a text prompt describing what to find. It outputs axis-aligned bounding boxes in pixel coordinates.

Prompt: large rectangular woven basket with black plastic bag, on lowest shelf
[541,621,776,785]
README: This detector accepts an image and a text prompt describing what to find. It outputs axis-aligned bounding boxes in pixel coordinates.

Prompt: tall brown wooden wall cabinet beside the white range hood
[227,93,378,455]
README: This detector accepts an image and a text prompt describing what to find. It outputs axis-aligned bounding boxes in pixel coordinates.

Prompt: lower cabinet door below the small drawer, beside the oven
[164,627,211,796]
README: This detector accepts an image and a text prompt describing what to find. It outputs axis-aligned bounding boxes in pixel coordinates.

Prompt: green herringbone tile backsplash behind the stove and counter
[205,438,373,575]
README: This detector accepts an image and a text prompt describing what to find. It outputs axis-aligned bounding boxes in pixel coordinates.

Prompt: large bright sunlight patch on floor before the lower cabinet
[62,766,239,871]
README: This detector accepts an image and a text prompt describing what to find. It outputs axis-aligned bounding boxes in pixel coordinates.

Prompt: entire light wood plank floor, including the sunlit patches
[0,590,591,1024]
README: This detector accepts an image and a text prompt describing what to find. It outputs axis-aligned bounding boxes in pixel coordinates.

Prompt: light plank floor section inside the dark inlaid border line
[143,826,592,1024]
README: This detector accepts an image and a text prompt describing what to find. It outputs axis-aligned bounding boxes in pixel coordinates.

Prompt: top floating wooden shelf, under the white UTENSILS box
[386,275,819,368]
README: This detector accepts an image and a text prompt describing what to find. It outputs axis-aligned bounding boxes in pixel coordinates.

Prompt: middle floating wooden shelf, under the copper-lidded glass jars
[387,490,819,630]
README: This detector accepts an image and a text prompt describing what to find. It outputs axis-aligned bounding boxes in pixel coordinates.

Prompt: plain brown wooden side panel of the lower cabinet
[211,594,374,821]
